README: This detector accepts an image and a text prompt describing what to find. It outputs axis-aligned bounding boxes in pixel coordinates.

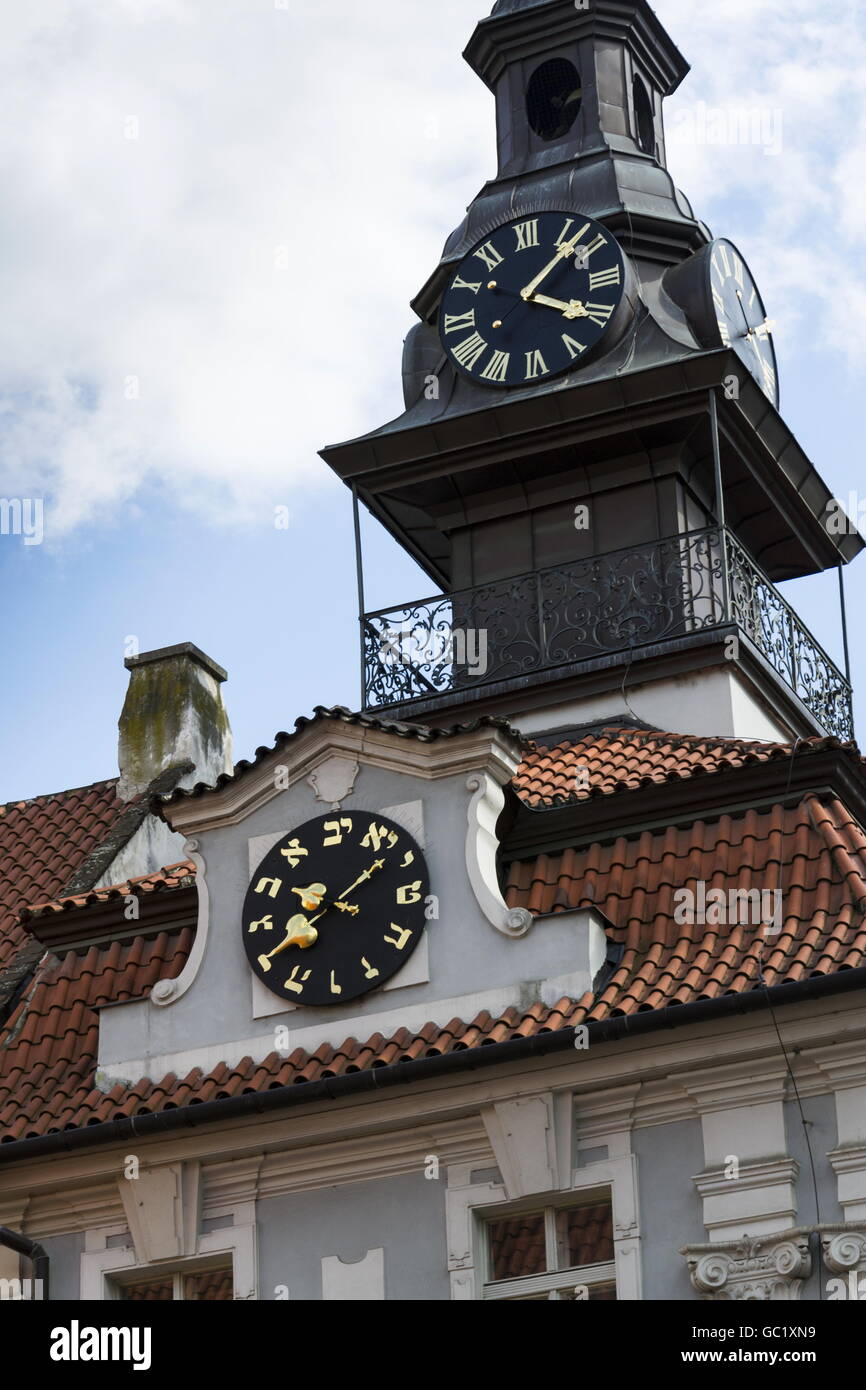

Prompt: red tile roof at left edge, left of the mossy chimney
[0,778,128,972]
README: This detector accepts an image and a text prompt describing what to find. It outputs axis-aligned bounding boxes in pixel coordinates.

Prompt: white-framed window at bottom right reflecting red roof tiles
[484,1191,616,1302]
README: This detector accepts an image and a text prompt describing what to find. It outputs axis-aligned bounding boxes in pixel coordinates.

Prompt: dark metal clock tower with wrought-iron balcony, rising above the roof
[322,0,863,739]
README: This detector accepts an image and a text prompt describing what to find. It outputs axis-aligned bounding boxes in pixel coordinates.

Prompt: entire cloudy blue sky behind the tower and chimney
[0,0,866,802]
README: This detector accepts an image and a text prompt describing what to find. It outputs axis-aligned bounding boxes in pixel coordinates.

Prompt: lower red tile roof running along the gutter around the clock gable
[0,796,866,1143]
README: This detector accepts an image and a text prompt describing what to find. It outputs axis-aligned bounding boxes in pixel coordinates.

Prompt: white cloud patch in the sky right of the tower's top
[656,0,866,371]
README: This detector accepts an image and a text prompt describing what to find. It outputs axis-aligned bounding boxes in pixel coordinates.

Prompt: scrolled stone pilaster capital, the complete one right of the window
[680,1227,812,1302]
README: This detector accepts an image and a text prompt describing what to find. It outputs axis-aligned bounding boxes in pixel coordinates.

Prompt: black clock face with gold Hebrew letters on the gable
[243,812,430,1005]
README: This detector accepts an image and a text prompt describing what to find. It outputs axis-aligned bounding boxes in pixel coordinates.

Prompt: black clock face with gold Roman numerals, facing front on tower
[439,213,626,386]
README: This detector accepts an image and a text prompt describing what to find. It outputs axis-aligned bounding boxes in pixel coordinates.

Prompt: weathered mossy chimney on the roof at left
[118,642,232,801]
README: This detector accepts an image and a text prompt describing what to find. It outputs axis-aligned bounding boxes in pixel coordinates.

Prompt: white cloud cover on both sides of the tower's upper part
[0,0,866,532]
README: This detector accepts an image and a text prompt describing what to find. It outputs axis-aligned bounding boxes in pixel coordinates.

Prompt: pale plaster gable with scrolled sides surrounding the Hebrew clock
[99,719,606,1087]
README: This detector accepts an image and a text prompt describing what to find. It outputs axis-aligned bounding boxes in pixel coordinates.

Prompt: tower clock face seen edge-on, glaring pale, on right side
[709,240,778,406]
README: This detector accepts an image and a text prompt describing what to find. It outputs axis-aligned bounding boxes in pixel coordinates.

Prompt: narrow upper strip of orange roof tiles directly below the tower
[514,724,856,808]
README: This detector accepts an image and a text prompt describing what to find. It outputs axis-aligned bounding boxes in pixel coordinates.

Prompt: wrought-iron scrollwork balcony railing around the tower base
[363,527,853,738]
